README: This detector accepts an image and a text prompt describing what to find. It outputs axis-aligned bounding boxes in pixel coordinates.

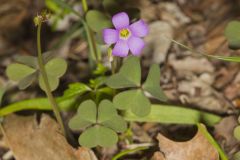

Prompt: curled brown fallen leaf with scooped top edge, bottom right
[153,124,219,160]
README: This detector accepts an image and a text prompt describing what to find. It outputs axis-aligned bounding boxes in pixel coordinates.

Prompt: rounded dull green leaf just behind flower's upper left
[86,10,112,32]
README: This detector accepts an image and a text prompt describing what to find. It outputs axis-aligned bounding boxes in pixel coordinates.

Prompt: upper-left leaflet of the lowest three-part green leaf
[68,100,97,130]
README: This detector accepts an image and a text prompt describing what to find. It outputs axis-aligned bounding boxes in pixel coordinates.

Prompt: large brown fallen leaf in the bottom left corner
[3,114,97,160]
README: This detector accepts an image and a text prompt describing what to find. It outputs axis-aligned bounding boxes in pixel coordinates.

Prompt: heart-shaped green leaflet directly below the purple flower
[106,56,141,89]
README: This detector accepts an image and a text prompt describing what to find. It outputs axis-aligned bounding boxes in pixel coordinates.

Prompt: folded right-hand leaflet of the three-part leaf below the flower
[143,64,167,101]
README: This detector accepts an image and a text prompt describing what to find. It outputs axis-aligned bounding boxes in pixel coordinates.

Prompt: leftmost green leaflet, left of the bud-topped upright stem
[6,63,36,81]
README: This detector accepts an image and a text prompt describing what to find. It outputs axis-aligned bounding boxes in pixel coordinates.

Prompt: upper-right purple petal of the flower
[129,20,148,37]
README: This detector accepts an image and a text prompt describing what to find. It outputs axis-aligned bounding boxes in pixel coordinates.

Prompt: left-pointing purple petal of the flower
[103,29,118,44]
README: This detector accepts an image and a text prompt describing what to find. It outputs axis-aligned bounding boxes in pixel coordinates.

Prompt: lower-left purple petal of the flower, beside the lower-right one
[112,40,129,57]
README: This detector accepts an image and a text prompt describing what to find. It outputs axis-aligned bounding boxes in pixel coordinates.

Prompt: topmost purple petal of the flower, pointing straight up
[112,12,129,29]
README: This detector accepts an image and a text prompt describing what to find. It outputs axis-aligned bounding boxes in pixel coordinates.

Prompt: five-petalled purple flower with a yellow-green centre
[103,12,148,57]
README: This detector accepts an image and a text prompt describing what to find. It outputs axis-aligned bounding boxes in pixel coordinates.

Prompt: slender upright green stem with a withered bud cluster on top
[37,23,66,136]
